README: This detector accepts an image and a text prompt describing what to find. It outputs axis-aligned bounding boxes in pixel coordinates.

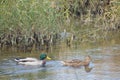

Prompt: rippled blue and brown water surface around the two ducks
[0,44,120,80]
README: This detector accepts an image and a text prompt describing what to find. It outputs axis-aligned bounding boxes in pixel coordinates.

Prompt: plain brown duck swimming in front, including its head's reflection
[62,56,94,72]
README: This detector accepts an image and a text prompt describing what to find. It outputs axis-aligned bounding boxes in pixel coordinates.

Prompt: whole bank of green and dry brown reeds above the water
[0,0,120,50]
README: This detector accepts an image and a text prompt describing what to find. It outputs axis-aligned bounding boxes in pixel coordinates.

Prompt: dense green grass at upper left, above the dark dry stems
[0,0,63,31]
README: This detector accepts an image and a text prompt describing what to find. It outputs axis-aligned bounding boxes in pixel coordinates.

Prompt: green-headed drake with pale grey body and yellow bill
[15,53,51,66]
